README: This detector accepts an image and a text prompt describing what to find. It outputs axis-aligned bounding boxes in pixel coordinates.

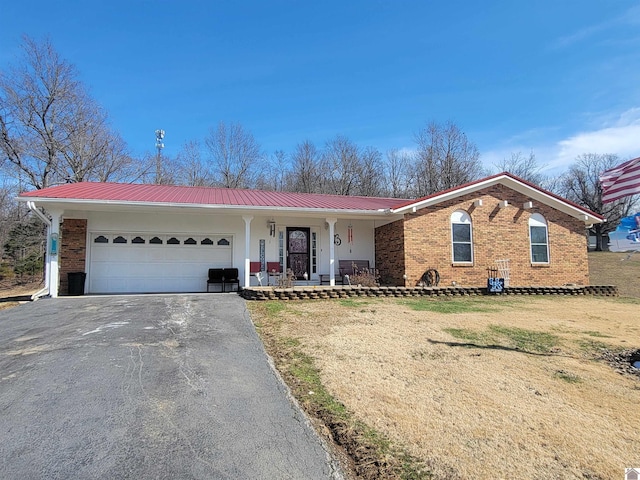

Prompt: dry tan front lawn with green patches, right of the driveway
[254,297,640,479]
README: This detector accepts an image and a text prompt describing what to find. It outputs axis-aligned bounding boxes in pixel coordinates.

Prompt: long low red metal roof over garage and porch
[20,182,407,211]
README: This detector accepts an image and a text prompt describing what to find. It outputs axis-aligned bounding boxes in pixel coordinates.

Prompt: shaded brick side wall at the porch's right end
[374,220,405,285]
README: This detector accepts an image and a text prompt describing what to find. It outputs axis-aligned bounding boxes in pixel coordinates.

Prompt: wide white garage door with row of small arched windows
[87,232,233,293]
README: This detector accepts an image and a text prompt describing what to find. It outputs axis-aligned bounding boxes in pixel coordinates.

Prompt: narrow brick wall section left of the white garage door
[58,218,87,295]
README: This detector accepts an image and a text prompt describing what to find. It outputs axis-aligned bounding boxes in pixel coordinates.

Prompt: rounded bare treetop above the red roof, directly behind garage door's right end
[205,122,262,188]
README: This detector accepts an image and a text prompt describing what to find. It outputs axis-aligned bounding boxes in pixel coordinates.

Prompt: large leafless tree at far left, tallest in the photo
[0,37,134,189]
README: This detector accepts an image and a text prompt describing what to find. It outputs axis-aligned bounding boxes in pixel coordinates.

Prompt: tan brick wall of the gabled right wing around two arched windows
[376,185,589,286]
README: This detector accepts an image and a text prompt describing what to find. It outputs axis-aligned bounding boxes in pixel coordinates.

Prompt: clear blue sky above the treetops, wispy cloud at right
[0,0,640,171]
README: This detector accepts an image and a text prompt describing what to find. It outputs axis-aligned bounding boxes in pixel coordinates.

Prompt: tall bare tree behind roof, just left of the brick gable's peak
[415,122,483,196]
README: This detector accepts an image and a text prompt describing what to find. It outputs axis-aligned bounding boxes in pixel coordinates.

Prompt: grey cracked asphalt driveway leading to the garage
[0,294,342,480]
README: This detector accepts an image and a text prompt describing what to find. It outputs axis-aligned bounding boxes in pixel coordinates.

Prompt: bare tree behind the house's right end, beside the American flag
[561,153,638,251]
